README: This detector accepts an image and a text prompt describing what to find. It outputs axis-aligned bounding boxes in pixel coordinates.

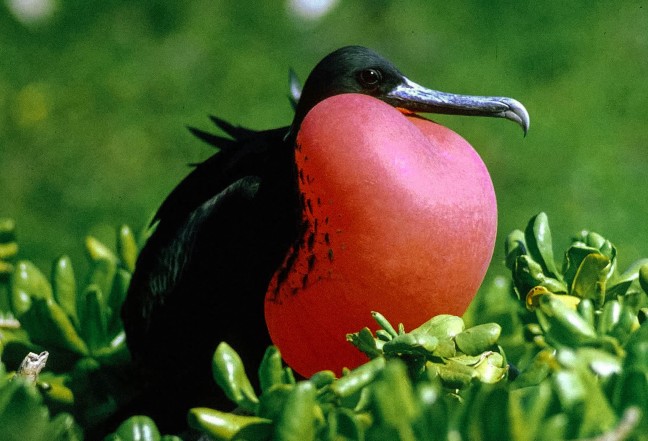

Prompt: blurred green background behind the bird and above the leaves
[0,0,648,284]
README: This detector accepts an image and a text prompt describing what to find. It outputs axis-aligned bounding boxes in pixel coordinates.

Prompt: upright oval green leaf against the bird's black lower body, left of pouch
[212,342,259,412]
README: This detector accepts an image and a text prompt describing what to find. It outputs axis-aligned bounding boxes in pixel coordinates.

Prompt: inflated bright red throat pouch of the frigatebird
[265,95,497,375]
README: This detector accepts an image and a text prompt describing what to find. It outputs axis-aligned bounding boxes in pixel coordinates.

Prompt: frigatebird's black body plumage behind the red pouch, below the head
[122,120,298,422]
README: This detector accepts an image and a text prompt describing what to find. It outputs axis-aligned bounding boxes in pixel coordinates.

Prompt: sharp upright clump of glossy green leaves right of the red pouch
[505,213,648,314]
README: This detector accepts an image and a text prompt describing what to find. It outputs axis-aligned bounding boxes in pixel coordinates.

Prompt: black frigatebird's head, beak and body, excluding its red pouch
[122,46,529,430]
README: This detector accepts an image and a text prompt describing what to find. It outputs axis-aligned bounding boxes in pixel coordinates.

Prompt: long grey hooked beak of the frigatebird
[383,78,530,135]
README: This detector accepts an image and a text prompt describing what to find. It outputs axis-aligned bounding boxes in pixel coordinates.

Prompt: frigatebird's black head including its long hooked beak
[291,46,529,134]
